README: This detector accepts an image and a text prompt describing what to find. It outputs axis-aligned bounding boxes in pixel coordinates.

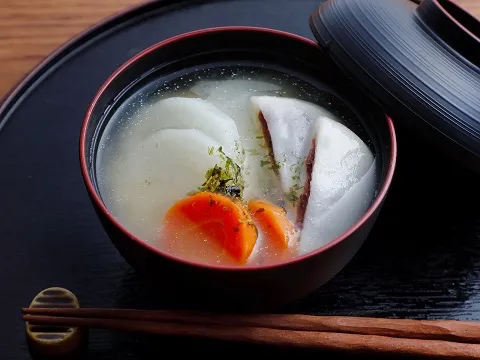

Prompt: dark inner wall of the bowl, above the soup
[82,28,392,265]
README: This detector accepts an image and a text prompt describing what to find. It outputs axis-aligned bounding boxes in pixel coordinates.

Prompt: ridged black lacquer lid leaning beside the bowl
[310,0,480,171]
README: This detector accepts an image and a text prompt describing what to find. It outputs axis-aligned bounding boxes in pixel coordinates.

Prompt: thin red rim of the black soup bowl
[80,26,397,271]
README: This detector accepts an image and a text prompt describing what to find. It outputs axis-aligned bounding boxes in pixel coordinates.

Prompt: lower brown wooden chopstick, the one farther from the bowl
[23,309,480,359]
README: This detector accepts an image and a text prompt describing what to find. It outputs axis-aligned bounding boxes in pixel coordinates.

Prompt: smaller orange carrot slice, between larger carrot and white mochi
[248,200,295,249]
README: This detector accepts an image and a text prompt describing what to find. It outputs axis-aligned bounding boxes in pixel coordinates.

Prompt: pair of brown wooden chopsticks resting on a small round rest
[22,308,480,359]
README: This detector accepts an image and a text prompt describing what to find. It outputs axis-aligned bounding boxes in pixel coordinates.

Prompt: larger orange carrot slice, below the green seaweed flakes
[165,192,258,263]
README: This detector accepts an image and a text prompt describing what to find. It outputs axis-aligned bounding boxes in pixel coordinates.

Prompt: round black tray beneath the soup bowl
[0,0,480,360]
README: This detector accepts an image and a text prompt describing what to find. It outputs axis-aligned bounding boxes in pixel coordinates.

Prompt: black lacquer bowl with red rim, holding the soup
[80,27,396,310]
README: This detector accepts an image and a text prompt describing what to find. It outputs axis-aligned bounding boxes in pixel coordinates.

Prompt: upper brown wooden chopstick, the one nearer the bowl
[22,308,480,344]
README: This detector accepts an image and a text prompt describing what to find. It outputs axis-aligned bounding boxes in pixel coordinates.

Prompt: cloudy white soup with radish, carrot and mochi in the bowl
[96,66,378,266]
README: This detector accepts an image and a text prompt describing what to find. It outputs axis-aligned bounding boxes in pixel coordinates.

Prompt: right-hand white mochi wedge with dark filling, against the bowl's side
[297,117,377,254]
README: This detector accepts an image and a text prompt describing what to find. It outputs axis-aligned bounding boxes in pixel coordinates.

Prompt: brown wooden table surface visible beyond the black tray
[0,0,480,98]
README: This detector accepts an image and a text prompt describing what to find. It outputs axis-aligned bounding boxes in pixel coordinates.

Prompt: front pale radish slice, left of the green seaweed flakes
[106,129,229,241]
